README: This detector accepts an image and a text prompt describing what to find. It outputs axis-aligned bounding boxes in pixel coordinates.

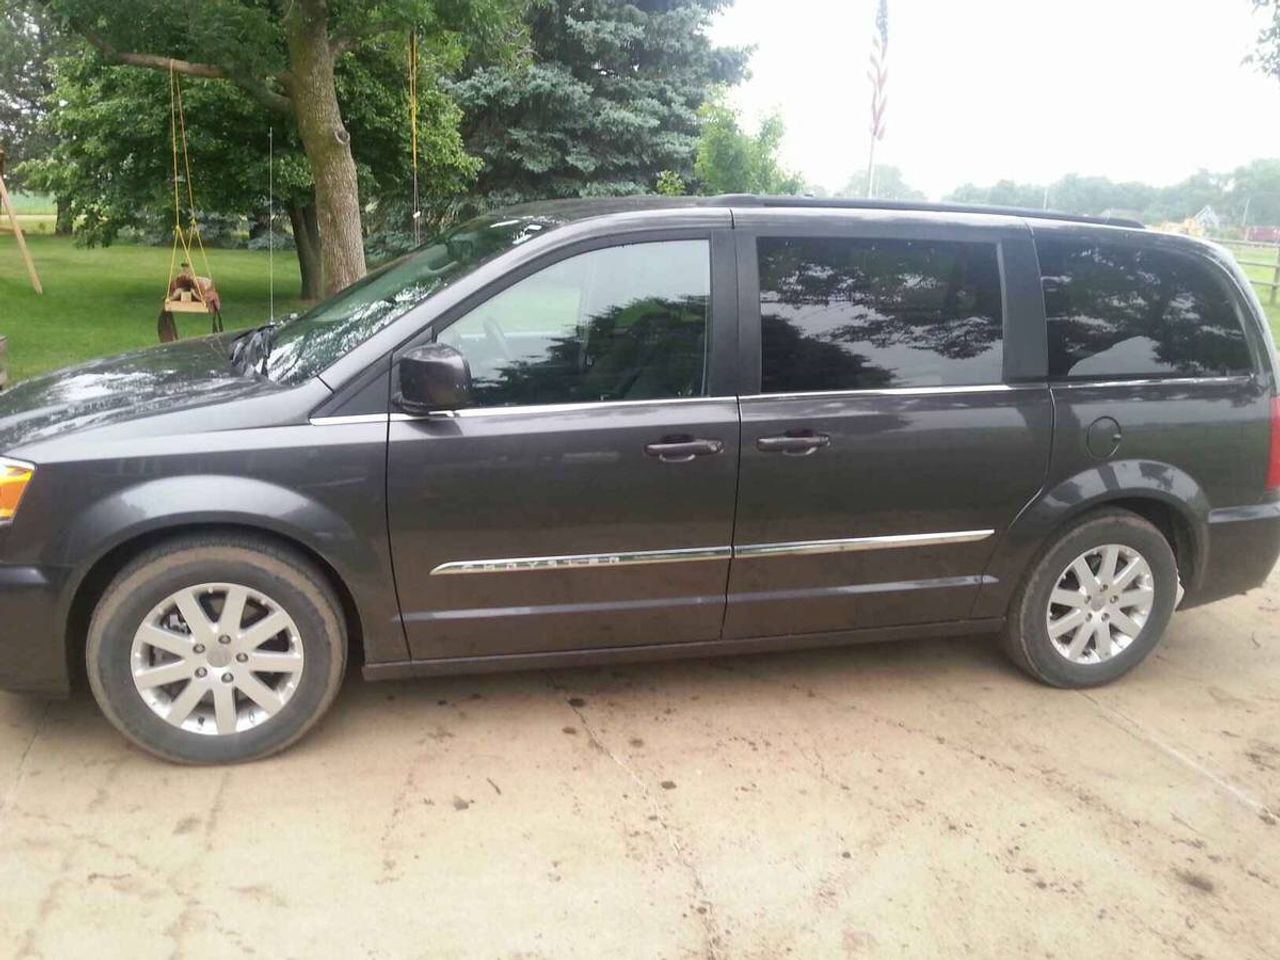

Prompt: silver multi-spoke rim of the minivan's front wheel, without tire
[132,584,303,736]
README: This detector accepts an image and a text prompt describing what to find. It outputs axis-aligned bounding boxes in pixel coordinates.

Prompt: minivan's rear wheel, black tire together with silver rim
[1005,508,1179,689]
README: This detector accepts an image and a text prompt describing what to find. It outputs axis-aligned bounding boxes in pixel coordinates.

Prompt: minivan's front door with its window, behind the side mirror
[388,232,739,659]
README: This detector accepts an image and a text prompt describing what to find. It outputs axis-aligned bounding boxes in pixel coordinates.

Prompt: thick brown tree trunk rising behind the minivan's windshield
[284,0,365,293]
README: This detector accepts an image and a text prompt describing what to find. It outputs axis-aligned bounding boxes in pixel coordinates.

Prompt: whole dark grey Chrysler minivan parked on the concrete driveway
[0,196,1280,763]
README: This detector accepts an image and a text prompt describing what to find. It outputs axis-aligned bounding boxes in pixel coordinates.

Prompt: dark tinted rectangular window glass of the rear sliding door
[758,237,1004,393]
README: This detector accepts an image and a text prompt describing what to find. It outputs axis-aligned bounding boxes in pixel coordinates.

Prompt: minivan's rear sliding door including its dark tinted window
[724,210,1052,637]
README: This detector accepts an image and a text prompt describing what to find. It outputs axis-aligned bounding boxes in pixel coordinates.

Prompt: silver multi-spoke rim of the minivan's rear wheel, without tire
[1046,544,1156,663]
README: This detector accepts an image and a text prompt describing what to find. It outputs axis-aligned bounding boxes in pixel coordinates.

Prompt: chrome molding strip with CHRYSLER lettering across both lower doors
[431,530,996,576]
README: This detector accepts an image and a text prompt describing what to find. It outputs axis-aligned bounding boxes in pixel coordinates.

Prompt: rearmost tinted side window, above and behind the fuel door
[1036,239,1253,380]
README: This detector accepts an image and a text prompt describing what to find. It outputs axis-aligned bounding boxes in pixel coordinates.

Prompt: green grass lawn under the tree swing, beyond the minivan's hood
[0,234,302,381]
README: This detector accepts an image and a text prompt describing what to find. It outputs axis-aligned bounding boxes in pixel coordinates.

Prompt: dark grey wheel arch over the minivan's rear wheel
[972,460,1210,618]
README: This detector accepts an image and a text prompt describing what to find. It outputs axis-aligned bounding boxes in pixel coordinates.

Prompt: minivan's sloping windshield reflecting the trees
[265,214,554,384]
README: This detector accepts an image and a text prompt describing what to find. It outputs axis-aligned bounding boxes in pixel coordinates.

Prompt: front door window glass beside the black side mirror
[439,241,710,407]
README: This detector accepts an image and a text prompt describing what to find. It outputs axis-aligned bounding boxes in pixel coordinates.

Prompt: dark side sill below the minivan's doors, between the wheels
[362,617,1005,680]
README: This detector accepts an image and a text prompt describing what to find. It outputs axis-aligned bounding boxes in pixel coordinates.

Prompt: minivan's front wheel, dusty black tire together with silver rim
[86,535,347,764]
